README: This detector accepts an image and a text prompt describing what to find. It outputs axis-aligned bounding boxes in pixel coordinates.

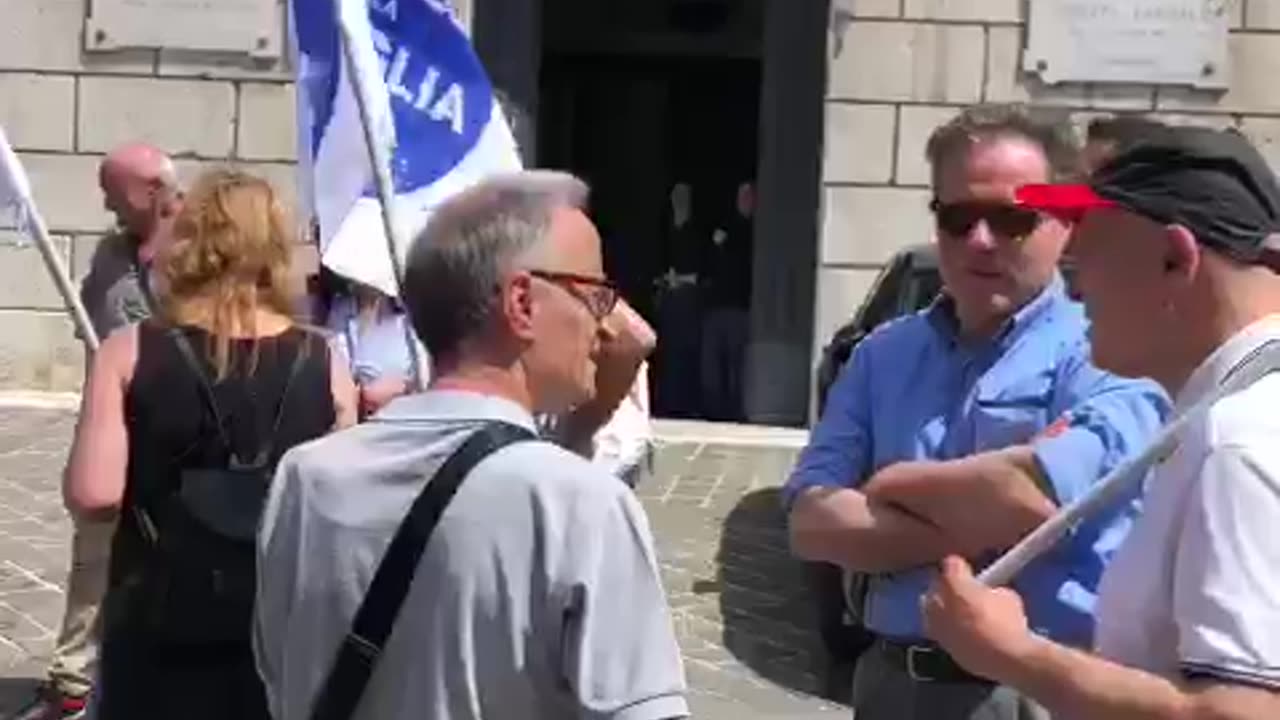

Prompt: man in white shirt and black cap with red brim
[924,128,1280,720]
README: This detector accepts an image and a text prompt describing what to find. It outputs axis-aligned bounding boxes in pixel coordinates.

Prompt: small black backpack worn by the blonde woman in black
[127,329,308,647]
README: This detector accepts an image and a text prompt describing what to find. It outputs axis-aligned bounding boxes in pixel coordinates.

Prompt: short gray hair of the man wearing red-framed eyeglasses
[404,170,589,356]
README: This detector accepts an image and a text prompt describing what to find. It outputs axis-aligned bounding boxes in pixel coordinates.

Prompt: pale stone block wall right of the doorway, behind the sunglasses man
[815,0,1280,358]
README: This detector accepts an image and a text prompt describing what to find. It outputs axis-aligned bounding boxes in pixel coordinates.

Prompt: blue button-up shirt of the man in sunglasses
[783,278,1169,647]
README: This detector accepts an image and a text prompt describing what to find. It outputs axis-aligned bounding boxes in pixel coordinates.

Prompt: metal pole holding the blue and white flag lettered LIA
[333,0,426,391]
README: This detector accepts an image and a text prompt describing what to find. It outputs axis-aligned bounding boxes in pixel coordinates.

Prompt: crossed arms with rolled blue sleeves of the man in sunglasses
[790,340,1167,573]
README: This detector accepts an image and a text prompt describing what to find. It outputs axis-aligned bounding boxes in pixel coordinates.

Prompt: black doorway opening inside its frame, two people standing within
[535,0,763,420]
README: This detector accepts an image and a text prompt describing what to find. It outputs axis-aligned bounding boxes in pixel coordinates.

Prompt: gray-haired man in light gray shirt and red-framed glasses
[253,172,689,720]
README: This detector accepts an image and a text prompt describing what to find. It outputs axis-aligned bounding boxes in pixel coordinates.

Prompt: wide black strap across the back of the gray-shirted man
[311,423,536,720]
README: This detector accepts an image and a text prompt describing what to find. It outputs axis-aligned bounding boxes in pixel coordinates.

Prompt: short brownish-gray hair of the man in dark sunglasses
[924,102,1082,186]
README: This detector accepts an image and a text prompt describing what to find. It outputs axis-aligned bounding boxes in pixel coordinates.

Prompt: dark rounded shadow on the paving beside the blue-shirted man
[717,488,844,701]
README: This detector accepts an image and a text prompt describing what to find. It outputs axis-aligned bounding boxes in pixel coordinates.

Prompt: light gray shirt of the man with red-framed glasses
[253,391,687,720]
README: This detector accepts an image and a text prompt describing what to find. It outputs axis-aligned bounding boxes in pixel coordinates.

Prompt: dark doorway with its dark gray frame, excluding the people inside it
[471,0,831,427]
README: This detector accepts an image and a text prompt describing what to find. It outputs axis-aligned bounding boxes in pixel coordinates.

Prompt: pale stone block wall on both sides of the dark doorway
[0,0,1280,421]
